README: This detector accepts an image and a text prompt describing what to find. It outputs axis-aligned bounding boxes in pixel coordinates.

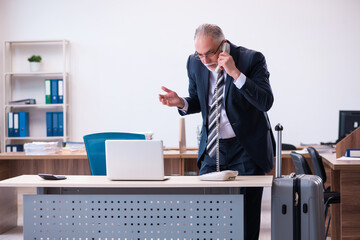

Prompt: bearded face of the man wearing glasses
[195,36,221,71]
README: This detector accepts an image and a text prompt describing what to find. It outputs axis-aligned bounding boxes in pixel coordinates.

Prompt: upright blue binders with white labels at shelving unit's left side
[8,112,29,137]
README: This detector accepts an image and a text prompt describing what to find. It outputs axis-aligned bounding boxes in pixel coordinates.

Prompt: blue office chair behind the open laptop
[83,132,145,175]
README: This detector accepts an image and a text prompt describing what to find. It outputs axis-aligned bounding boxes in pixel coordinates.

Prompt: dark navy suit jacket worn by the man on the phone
[179,41,275,172]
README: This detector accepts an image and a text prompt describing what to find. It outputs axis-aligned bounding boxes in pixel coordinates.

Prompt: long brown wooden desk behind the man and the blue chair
[0,150,311,180]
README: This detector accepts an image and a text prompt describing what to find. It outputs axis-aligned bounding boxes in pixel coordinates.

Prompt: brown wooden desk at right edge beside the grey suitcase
[321,153,360,240]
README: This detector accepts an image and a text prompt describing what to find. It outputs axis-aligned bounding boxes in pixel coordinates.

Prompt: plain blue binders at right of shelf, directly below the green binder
[46,112,64,137]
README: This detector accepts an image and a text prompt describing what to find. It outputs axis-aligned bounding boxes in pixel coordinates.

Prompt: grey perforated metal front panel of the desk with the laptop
[24,195,243,240]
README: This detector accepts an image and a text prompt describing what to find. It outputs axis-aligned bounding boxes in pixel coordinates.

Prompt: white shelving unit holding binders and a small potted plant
[1,40,70,152]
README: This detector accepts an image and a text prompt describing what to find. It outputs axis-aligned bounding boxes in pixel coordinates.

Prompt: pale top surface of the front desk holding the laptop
[0,175,273,188]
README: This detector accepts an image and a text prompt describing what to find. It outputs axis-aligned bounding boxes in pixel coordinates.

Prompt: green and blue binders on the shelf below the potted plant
[45,79,64,104]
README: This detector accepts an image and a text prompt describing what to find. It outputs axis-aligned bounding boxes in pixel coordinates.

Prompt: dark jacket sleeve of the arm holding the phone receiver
[239,52,274,112]
